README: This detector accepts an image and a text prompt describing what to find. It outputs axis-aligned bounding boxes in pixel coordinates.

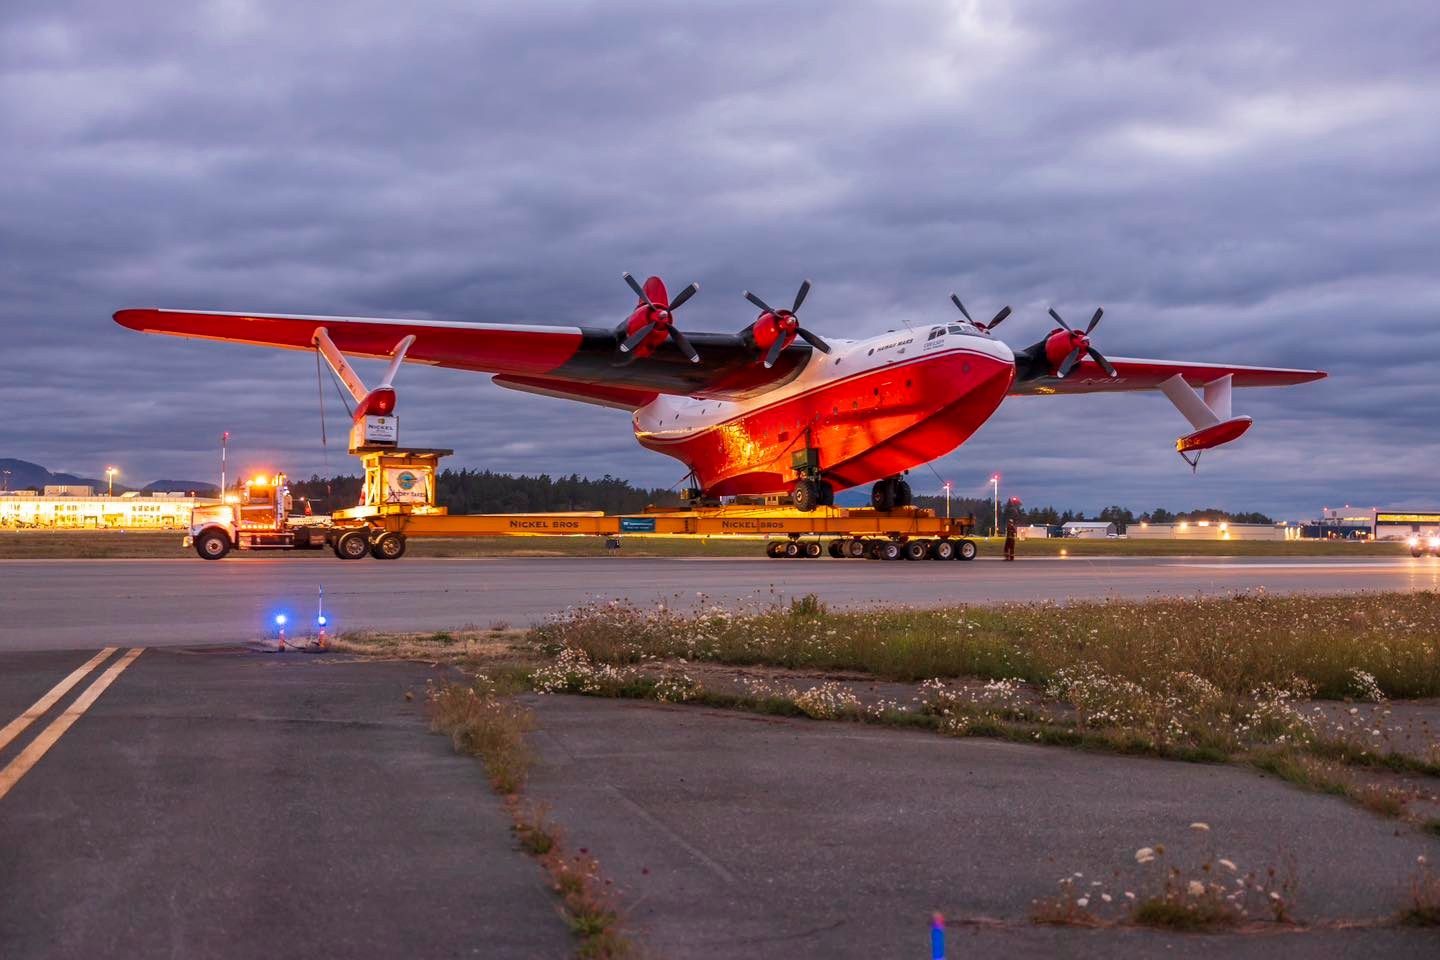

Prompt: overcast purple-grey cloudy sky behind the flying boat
[0,0,1440,517]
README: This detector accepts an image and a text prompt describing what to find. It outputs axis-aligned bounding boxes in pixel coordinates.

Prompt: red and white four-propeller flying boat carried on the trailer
[115,273,1325,510]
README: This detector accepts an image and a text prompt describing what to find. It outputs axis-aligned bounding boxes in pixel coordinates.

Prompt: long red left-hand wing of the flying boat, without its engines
[115,308,812,406]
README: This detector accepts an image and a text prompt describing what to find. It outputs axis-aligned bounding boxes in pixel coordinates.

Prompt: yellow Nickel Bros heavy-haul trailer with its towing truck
[186,446,976,560]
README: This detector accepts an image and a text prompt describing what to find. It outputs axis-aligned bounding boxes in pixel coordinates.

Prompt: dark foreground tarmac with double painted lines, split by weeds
[0,648,1440,960]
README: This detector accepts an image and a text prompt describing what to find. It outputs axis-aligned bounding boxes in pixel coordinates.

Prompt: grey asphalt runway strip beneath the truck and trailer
[0,554,1440,651]
